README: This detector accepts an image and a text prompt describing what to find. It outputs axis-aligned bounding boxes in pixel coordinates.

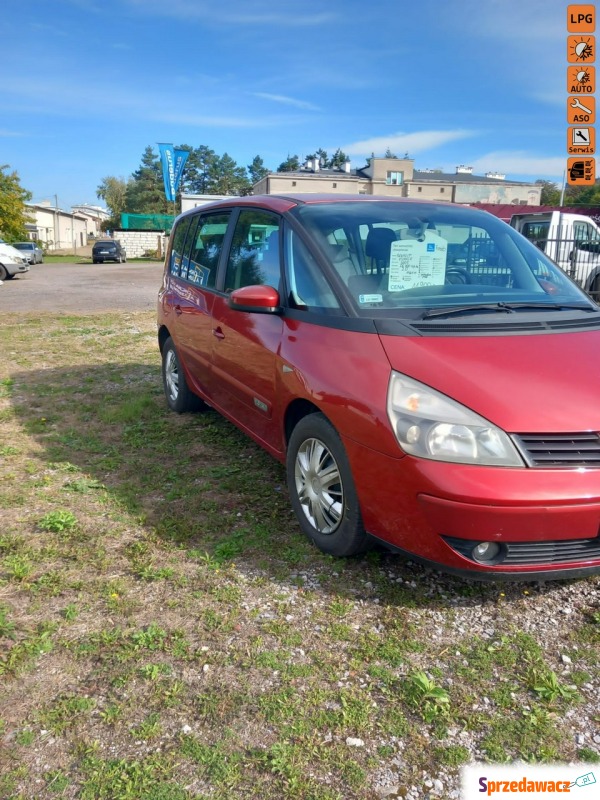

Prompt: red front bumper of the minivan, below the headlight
[344,440,600,579]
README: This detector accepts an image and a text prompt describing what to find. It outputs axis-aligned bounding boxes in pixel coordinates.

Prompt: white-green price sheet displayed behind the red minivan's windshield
[388,231,448,292]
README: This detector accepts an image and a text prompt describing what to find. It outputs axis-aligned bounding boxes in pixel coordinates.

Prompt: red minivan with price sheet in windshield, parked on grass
[158,194,600,580]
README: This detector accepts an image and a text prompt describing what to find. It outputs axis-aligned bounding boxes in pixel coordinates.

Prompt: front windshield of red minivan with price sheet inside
[292,200,597,317]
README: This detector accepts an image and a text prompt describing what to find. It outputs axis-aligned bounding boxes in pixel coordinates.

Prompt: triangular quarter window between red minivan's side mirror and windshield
[285,227,340,313]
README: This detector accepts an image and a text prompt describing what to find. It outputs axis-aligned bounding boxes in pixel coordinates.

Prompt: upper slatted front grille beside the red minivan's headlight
[512,432,600,467]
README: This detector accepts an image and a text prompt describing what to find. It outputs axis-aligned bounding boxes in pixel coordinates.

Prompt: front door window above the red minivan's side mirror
[225,208,281,292]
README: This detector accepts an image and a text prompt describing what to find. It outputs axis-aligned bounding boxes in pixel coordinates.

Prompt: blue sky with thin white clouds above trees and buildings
[0,0,568,208]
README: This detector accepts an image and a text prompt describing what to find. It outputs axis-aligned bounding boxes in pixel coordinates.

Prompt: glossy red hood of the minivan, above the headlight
[380,331,600,433]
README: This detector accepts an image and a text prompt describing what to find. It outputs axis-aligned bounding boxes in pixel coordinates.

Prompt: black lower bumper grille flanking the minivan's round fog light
[442,536,600,567]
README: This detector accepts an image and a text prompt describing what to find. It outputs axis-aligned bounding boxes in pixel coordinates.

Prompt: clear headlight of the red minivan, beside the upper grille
[387,372,525,467]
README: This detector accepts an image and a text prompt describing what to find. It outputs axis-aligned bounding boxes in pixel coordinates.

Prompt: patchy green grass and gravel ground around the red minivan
[0,313,600,800]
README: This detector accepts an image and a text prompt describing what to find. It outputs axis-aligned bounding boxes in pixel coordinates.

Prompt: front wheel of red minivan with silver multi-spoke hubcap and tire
[286,413,369,556]
